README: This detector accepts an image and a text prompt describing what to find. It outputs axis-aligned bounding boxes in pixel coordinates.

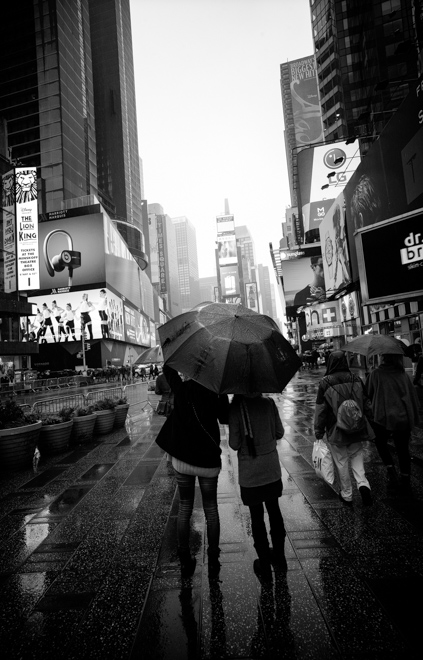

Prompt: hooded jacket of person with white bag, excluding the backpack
[314,351,375,446]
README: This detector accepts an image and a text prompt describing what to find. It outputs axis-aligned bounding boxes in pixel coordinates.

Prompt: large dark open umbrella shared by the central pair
[159,303,301,394]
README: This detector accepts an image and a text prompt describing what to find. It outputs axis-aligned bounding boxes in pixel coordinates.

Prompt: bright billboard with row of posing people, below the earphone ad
[28,289,125,344]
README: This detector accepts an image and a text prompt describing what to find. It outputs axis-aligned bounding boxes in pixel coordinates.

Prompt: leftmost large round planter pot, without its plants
[0,421,41,470]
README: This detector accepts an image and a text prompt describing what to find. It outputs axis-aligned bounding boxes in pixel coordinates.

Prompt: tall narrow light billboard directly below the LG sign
[319,193,351,296]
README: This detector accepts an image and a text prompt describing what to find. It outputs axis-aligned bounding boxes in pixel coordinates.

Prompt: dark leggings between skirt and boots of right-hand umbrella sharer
[249,499,286,558]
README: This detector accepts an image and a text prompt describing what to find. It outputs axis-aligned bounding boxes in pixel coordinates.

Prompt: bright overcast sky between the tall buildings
[130,0,313,283]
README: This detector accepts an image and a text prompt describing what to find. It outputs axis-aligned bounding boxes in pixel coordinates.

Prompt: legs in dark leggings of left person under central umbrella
[175,470,220,555]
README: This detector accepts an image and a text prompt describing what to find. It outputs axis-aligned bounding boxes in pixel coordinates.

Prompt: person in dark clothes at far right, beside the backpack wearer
[366,355,419,495]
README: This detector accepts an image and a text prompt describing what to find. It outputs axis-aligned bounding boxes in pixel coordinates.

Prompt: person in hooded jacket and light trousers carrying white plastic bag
[314,351,375,506]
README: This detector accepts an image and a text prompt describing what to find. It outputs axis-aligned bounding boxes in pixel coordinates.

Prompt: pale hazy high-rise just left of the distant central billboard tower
[172,216,201,312]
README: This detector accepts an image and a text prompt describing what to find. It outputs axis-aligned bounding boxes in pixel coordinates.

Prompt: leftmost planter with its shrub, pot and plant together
[0,399,41,470]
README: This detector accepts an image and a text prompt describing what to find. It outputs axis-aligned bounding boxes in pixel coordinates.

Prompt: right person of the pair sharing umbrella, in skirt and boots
[229,394,287,582]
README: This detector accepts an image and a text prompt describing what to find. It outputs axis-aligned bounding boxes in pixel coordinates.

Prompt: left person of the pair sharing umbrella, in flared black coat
[156,365,229,576]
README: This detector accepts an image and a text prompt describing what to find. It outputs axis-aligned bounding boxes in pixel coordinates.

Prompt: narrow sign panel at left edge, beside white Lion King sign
[2,170,16,293]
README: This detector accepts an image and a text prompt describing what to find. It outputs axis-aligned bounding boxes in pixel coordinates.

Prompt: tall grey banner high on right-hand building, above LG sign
[287,55,323,146]
